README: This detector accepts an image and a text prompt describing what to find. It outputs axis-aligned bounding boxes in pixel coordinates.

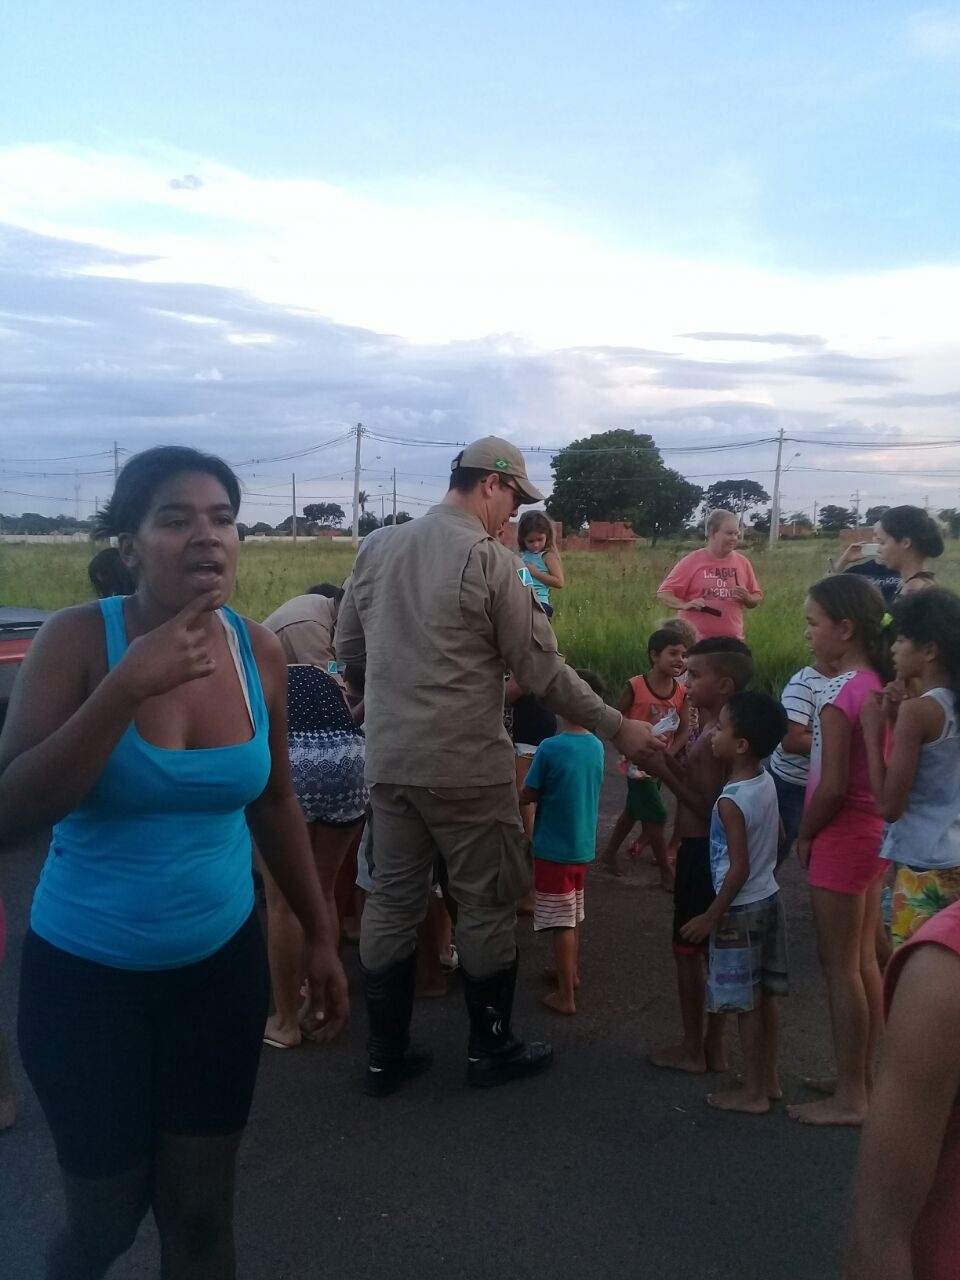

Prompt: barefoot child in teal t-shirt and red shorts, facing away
[521,671,604,1014]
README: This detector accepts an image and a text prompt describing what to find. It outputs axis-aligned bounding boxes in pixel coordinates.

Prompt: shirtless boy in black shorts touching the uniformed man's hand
[644,636,754,1073]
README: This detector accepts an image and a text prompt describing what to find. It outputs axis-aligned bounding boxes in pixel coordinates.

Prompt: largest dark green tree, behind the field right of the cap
[547,430,703,539]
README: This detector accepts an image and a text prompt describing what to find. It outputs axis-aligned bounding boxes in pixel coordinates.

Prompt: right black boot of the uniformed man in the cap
[460,960,553,1089]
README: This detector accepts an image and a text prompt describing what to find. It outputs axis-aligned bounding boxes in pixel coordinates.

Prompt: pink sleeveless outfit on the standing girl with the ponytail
[805,671,887,893]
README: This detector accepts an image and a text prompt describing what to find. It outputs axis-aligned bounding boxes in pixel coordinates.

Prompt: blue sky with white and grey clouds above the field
[0,0,960,524]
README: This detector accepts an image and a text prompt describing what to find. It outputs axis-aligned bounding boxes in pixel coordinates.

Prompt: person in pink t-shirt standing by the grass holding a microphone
[657,509,763,640]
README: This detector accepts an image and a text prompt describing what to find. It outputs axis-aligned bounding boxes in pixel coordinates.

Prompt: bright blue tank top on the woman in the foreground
[31,596,270,969]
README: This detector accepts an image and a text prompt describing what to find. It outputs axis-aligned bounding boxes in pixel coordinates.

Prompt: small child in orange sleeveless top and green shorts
[602,628,690,892]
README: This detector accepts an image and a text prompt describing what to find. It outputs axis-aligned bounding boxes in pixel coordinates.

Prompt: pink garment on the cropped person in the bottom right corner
[883,902,960,1280]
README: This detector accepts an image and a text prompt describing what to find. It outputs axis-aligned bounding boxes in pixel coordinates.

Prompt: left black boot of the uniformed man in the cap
[360,951,433,1098]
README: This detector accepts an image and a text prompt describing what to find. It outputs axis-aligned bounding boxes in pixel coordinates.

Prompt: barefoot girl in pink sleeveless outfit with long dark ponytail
[788,573,887,1125]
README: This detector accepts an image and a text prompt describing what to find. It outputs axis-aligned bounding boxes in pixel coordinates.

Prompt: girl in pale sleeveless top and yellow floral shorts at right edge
[860,588,960,946]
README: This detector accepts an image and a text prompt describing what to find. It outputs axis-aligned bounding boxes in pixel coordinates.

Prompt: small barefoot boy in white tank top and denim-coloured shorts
[680,692,787,1115]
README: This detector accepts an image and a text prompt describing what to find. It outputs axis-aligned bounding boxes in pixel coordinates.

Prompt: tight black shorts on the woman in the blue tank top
[18,911,269,1178]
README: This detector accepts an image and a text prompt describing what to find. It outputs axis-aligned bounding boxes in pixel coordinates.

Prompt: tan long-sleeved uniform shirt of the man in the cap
[337,504,622,787]
